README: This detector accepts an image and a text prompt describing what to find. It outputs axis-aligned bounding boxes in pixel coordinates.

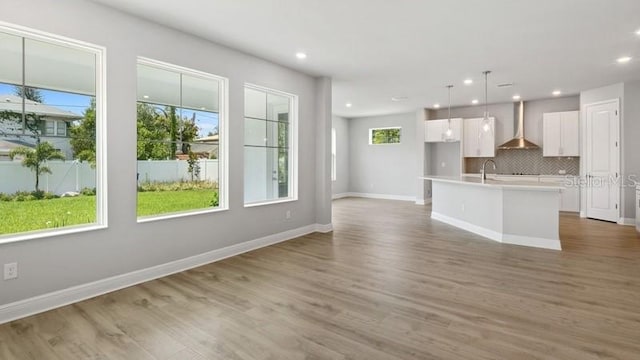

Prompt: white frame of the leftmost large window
[0,21,108,244]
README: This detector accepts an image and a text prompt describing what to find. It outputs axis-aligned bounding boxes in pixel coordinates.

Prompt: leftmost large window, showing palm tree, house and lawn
[0,26,106,242]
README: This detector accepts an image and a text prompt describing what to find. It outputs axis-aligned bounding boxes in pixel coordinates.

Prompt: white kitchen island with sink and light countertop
[421,176,562,250]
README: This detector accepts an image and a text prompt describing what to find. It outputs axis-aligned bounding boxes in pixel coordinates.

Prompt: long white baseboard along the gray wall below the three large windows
[0,224,333,324]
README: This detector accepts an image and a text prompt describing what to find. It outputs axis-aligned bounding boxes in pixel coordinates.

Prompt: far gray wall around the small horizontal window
[348,113,416,197]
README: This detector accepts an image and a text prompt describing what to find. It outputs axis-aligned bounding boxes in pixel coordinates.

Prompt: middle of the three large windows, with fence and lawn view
[137,59,226,219]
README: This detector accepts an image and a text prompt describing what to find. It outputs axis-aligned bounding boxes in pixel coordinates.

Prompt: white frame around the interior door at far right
[580,98,623,224]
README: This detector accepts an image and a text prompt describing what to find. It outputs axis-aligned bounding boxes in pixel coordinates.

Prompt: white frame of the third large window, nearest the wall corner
[242,83,298,208]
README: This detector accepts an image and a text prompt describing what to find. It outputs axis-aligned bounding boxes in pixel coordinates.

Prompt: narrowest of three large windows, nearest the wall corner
[244,85,298,205]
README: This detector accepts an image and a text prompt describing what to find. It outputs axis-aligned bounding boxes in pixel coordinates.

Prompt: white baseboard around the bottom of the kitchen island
[431,211,561,250]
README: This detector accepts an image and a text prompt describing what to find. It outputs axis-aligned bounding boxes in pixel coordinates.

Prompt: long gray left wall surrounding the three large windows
[0,0,331,305]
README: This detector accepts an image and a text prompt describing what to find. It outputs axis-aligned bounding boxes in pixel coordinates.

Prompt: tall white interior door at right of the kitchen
[585,100,620,222]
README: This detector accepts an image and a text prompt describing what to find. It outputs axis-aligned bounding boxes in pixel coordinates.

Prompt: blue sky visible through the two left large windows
[0,83,218,137]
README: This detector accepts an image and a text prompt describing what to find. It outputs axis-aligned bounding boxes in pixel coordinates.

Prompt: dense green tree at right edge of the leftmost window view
[69,98,96,167]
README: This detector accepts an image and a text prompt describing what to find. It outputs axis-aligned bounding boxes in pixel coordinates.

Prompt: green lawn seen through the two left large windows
[0,189,218,234]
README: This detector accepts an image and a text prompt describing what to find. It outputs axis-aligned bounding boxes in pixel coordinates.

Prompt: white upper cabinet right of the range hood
[542,111,580,156]
